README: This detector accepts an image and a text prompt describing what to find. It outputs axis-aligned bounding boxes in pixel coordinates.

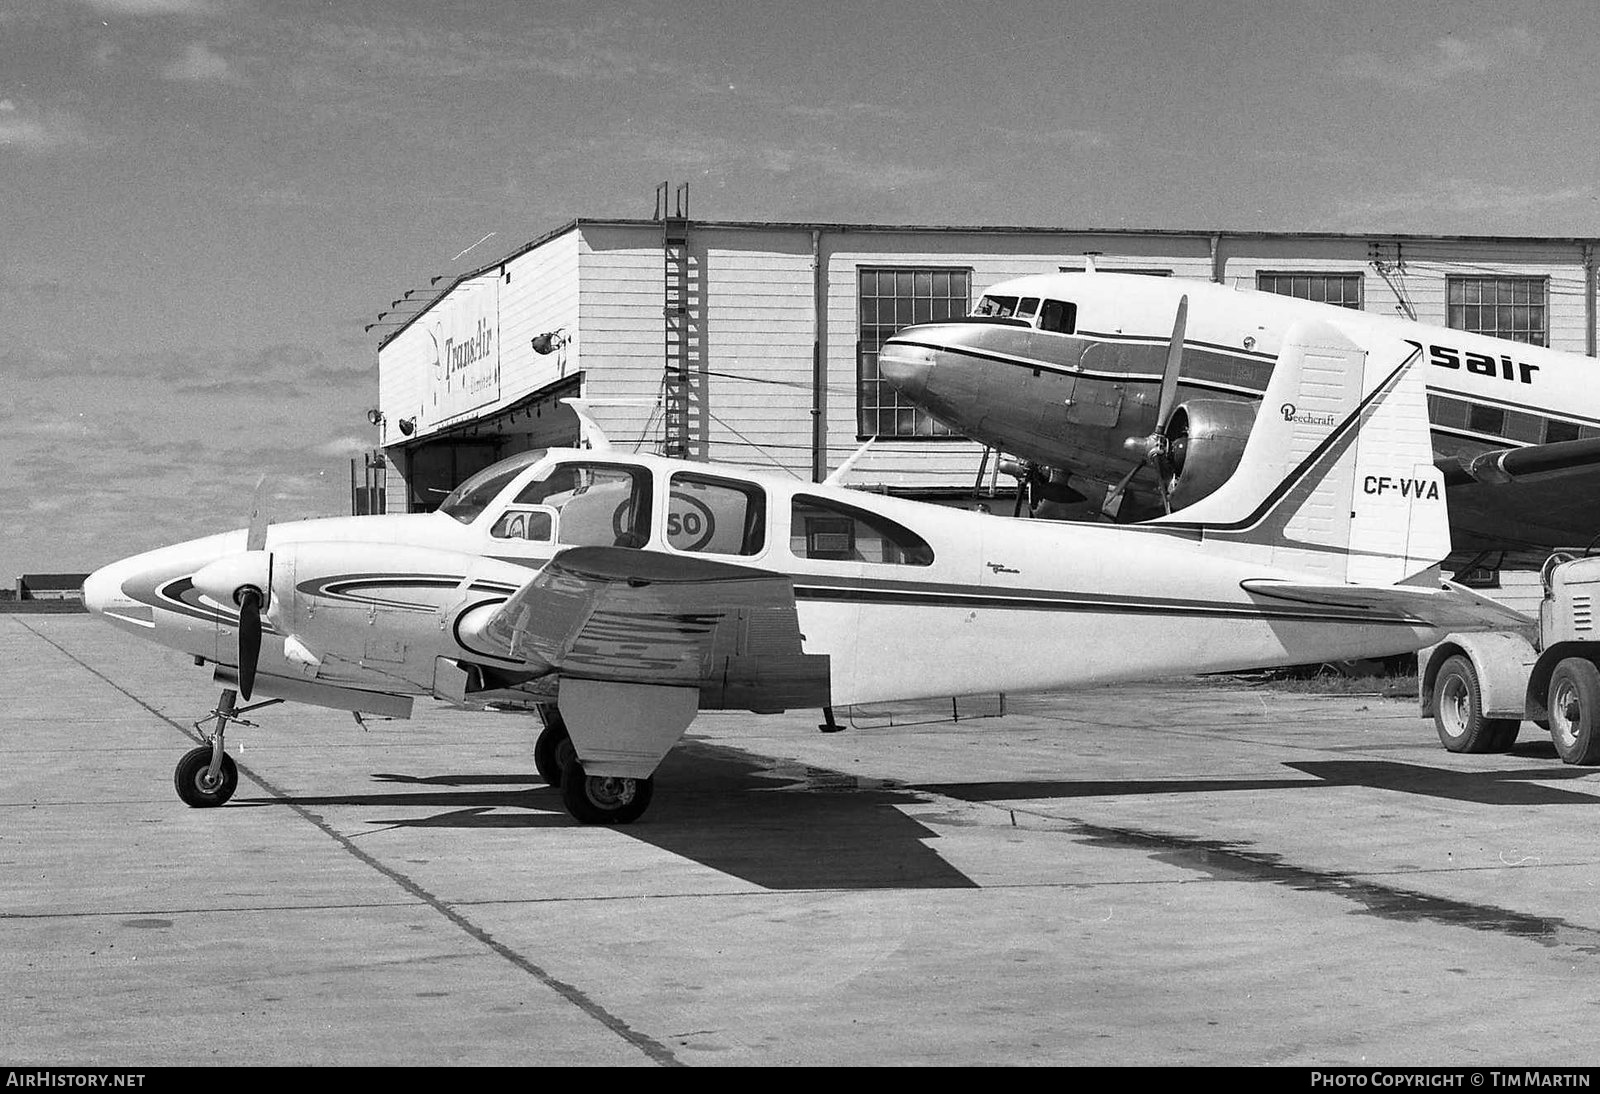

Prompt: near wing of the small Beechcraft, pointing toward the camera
[474,547,829,713]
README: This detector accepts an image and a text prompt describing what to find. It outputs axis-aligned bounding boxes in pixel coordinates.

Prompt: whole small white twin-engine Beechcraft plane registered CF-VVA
[83,323,1522,824]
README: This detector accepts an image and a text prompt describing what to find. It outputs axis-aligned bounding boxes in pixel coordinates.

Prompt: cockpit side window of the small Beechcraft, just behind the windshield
[512,464,650,547]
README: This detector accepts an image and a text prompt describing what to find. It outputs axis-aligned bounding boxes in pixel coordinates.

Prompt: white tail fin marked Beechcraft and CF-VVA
[1150,320,1450,585]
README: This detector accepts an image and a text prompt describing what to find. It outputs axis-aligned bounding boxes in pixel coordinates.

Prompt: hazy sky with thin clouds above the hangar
[0,0,1600,582]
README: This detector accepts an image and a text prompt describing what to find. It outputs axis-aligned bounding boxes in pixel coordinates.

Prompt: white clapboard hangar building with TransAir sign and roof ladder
[366,206,1595,543]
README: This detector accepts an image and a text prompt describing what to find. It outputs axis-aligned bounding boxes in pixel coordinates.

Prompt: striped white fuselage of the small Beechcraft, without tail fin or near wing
[85,449,1465,710]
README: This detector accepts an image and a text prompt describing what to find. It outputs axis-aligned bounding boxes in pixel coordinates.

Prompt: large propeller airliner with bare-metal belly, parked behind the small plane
[878,272,1600,552]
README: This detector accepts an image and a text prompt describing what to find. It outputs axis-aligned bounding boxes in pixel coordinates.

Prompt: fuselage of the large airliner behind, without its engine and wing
[878,274,1600,542]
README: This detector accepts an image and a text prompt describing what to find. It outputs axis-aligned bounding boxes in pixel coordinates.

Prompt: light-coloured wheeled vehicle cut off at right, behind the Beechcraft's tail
[1418,553,1600,765]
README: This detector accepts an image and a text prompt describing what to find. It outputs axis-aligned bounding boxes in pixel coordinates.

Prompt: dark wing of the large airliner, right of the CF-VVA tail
[1435,437,1600,550]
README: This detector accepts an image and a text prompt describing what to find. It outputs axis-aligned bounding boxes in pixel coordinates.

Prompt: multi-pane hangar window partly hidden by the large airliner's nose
[856,267,966,440]
